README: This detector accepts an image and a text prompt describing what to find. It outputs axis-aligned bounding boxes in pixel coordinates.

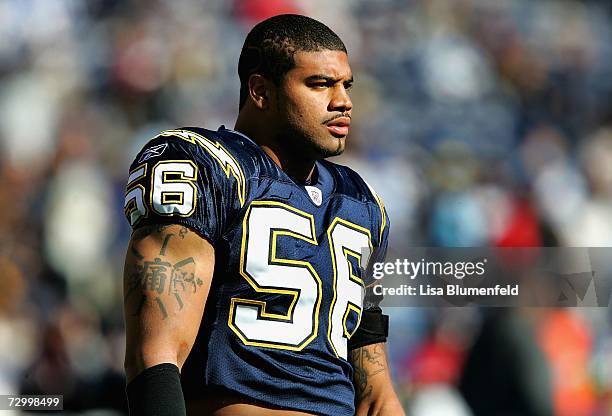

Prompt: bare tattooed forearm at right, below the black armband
[349,343,404,416]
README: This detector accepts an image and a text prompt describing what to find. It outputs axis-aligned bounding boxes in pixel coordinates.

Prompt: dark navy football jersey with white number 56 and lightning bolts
[125,128,389,415]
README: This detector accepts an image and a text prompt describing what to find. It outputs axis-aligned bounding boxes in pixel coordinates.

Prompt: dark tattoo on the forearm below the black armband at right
[350,344,386,401]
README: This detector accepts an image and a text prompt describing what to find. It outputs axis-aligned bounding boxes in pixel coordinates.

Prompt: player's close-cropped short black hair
[238,14,346,108]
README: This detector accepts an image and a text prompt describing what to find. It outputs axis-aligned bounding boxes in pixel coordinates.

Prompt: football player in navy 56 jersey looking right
[124,15,403,416]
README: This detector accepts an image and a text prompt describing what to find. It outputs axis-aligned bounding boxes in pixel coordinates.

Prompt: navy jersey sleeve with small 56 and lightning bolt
[124,133,239,245]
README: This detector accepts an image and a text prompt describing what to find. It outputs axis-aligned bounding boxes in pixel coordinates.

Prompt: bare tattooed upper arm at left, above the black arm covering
[124,225,214,382]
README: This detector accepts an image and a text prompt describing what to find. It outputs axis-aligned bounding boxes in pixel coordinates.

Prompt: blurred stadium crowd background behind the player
[0,0,612,416]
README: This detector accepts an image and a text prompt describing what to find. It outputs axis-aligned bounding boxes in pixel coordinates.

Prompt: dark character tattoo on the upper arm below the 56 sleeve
[125,226,204,319]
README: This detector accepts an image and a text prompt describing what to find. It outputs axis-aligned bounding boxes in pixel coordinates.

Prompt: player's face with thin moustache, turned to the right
[273,50,353,159]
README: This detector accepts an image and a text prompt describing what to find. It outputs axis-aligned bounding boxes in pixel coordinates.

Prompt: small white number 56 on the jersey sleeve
[123,160,198,225]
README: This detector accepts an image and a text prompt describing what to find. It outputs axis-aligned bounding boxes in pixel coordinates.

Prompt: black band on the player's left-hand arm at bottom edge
[126,363,187,416]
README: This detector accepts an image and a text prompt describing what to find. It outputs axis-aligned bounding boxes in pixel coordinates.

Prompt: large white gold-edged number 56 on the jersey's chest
[228,201,372,359]
